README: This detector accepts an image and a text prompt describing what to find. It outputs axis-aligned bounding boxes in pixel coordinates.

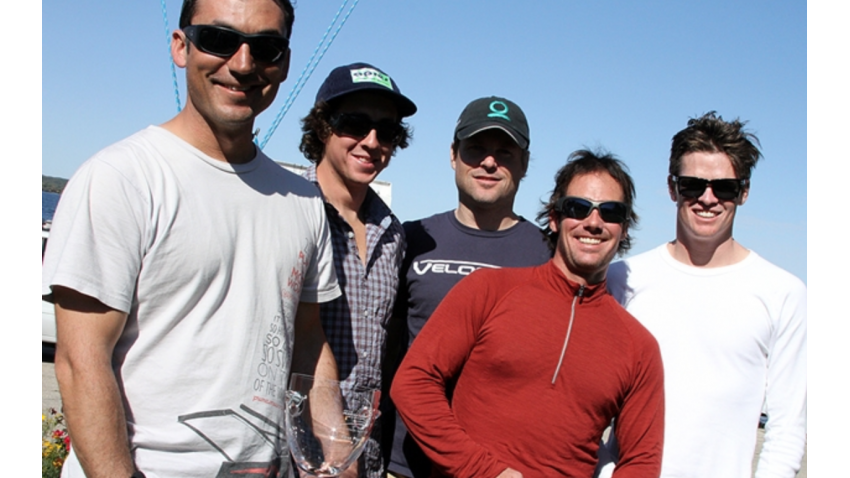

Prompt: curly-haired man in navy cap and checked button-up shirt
[300,63,416,478]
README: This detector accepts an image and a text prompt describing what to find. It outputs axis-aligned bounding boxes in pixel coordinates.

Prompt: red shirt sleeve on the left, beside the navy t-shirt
[391,271,508,478]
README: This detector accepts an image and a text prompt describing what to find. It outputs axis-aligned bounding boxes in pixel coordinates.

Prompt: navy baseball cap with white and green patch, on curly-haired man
[316,63,416,118]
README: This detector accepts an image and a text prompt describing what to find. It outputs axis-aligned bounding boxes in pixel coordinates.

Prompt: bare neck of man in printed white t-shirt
[162,103,257,164]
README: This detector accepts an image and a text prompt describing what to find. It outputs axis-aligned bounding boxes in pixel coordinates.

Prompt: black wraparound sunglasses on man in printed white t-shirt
[183,25,289,63]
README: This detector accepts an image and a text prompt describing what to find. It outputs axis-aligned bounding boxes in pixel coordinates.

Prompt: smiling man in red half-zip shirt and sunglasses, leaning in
[392,151,664,478]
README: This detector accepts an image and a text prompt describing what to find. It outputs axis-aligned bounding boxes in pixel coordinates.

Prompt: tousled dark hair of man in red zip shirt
[537,149,638,255]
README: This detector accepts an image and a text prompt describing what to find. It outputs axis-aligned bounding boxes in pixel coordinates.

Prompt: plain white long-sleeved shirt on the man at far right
[608,244,808,478]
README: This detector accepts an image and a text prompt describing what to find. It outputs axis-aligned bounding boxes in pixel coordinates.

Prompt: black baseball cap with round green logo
[455,96,531,149]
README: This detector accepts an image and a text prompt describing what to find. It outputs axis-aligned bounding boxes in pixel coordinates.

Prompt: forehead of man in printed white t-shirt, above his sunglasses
[191,0,286,36]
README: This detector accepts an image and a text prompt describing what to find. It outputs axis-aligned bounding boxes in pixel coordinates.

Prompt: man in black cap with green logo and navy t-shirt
[388,96,551,478]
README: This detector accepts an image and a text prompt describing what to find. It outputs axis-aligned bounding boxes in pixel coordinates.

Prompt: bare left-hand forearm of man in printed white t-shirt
[56,347,135,478]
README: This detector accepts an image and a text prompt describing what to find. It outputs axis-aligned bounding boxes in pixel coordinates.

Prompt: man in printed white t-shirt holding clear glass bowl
[42,0,340,478]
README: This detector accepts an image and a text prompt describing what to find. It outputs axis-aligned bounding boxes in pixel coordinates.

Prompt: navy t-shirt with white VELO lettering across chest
[386,211,552,478]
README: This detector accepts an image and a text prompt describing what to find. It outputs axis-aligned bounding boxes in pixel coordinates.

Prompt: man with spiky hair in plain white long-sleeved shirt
[608,112,808,478]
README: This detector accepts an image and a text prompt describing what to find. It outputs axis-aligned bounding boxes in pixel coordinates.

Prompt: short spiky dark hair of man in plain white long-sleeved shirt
[670,111,762,179]
